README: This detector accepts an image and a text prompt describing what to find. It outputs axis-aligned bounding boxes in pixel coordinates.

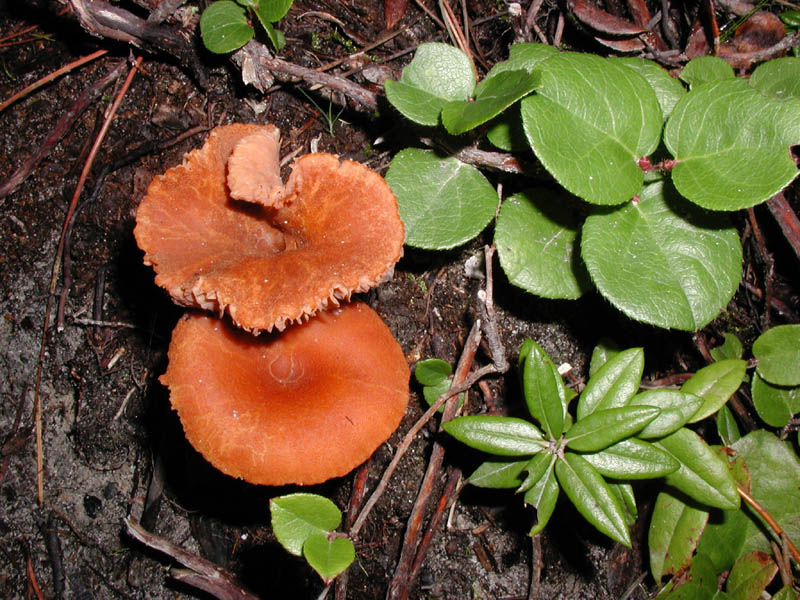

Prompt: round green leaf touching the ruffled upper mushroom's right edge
[386,148,497,250]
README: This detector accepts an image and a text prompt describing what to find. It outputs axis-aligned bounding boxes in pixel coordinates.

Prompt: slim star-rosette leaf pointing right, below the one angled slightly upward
[583,436,680,479]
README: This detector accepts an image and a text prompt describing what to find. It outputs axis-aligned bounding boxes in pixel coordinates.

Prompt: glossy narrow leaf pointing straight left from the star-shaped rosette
[442,415,547,456]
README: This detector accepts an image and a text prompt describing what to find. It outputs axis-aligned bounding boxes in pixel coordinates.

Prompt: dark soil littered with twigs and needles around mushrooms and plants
[0,0,796,599]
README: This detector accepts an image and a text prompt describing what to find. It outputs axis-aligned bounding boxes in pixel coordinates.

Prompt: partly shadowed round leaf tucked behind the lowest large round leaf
[494,188,592,299]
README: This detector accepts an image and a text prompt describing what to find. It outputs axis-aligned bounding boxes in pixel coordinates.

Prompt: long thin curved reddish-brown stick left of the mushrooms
[33,57,142,506]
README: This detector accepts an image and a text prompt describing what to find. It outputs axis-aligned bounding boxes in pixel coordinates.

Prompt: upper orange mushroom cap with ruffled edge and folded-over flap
[134,125,404,332]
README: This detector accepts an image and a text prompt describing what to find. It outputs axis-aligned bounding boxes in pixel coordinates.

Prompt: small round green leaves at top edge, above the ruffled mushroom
[200,0,293,54]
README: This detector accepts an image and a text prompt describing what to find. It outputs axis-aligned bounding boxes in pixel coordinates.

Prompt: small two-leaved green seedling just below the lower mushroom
[269,493,356,585]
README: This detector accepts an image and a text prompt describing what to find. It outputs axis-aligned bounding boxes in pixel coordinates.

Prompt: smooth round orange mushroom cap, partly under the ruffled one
[161,302,409,485]
